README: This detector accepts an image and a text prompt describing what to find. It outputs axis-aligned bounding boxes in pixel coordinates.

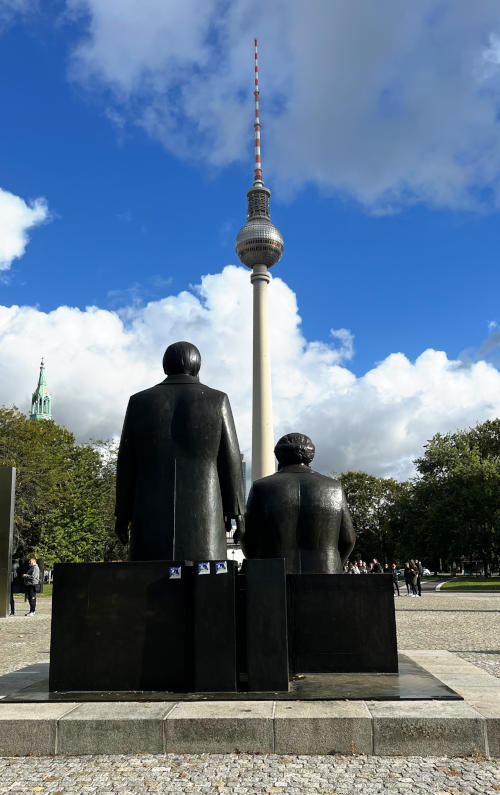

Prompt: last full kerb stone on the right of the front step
[367,701,487,756]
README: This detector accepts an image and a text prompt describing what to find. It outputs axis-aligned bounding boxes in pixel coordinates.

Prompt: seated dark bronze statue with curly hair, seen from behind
[241,433,356,574]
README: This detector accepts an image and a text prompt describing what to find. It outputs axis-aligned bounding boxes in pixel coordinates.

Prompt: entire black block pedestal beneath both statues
[50,559,398,693]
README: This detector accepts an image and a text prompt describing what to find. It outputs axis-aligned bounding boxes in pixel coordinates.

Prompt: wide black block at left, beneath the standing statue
[50,561,193,691]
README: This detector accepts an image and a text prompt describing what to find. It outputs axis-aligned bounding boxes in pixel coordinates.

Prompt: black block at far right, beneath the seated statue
[287,574,398,673]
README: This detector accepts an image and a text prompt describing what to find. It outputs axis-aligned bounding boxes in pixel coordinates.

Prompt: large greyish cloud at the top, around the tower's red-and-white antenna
[66,0,500,212]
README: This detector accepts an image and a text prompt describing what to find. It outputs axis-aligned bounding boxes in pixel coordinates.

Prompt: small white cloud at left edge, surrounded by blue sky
[0,188,49,271]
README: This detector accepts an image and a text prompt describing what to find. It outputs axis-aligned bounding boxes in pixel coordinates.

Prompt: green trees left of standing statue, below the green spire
[0,407,124,566]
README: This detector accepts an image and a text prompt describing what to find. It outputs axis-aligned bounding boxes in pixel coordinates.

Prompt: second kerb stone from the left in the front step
[57,701,173,755]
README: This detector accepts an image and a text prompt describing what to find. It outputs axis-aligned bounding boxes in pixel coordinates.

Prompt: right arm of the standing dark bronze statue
[217,395,245,532]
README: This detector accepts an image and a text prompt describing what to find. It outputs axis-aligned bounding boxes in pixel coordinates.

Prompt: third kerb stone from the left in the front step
[164,701,274,753]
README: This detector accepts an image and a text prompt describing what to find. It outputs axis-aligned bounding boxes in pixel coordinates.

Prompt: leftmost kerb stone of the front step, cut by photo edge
[0,702,77,756]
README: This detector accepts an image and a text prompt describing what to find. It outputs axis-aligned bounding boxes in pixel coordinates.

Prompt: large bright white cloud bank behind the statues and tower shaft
[0,266,500,478]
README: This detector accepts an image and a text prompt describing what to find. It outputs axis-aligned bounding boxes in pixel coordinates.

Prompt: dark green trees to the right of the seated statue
[340,419,500,572]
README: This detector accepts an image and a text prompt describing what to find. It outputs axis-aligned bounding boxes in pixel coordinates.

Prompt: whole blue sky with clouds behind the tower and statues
[0,0,500,476]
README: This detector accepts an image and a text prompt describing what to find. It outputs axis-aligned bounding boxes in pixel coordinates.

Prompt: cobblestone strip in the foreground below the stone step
[0,754,500,795]
